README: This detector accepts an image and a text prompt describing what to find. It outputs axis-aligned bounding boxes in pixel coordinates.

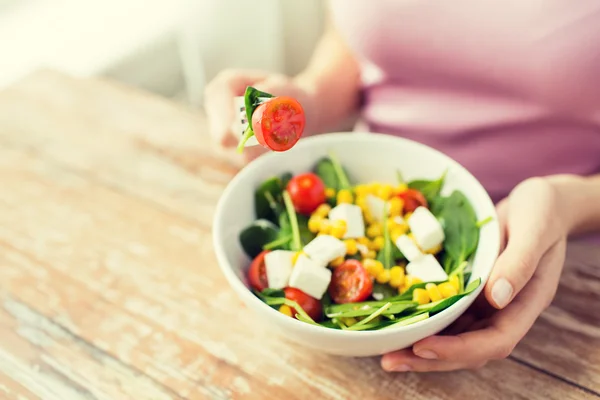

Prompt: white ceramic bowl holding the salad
[213,132,500,356]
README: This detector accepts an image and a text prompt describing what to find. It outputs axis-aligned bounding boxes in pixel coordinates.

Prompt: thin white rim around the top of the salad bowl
[212,131,500,338]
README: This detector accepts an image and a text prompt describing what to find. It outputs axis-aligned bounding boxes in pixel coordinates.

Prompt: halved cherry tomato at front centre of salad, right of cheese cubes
[329,260,373,304]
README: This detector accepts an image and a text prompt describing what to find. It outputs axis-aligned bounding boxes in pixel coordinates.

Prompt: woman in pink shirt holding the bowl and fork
[206,0,600,371]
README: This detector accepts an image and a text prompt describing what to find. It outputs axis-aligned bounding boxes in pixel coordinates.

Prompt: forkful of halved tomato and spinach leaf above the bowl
[238,86,306,152]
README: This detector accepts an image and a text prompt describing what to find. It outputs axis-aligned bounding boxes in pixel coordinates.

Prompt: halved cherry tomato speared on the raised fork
[252,96,306,151]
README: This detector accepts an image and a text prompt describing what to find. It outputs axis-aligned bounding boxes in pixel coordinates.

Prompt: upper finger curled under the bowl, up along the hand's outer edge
[413,242,565,365]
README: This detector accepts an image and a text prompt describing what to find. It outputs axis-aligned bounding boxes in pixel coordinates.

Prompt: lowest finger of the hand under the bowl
[381,349,475,372]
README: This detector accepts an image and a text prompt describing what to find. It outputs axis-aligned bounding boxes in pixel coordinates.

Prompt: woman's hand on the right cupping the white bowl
[381,178,570,371]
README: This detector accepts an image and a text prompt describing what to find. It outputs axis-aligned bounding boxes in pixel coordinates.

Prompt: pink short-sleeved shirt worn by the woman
[332,0,600,200]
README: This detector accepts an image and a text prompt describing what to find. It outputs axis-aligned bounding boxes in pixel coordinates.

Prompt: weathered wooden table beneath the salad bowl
[0,71,600,400]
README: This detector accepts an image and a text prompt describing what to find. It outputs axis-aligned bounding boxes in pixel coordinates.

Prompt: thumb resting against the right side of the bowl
[485,179,559,308]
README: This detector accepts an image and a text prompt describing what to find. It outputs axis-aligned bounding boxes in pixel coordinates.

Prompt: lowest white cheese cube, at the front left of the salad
[289,254,331,300]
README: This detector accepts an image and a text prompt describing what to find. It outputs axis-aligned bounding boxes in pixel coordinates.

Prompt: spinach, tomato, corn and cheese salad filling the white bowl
[239,154,490,331]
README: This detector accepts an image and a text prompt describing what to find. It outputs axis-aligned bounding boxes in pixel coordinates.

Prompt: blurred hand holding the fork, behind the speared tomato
[205,70,313,161]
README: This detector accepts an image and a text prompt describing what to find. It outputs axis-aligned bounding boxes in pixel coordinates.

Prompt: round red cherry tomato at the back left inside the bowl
[287,172,326,215]
